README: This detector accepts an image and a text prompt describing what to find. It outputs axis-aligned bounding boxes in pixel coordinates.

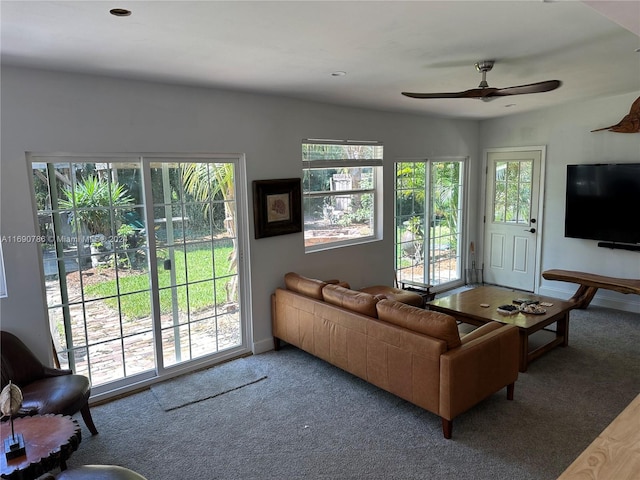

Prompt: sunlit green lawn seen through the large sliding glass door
[85,247,234,319]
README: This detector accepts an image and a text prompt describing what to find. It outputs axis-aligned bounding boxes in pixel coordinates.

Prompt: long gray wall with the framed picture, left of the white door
[0,67,480,359]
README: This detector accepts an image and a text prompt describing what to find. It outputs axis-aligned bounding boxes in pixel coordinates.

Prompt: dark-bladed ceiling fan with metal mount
[402,60,562,102]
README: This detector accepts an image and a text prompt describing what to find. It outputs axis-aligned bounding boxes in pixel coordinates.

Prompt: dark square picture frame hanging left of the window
[253,178,302,238]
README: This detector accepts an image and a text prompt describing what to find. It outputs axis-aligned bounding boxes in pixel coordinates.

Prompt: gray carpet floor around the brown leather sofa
[68,306,640,480]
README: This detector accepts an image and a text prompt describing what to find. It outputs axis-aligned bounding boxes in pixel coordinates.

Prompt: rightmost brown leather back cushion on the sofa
[376,299,462,349]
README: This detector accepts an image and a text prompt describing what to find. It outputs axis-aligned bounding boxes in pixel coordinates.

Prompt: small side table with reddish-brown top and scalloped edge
[0,415,82,480]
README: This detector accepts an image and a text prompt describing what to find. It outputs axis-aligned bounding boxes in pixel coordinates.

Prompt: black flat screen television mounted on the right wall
[564,163,640,244]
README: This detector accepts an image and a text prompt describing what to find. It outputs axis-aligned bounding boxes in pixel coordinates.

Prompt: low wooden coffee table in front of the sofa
[426,287,575,372]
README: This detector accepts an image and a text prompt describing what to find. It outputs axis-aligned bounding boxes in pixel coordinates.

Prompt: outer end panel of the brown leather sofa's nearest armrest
[440,325,520,420]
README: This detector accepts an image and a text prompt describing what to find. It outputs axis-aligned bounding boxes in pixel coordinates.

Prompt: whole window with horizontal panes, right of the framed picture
[302,140,383,252]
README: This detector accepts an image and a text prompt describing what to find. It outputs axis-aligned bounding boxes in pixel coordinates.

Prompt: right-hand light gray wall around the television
[480,93,640,313]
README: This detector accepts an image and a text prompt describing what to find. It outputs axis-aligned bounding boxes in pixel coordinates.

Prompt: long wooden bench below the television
[542,270,640,308]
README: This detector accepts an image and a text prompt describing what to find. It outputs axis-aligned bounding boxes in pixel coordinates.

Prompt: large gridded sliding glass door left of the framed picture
[30,155,248,398]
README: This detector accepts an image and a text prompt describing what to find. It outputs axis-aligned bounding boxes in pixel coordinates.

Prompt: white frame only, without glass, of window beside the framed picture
[302,139,384,253]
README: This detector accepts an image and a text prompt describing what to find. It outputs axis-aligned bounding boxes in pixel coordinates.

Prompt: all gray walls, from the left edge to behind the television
[0,67,640,359]
